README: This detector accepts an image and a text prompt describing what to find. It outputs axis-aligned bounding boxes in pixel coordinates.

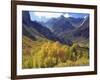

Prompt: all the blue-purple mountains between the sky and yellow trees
[22,11,89,45]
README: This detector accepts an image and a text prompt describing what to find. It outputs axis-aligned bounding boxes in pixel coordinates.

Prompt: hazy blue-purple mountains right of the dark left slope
[43,15,89,40]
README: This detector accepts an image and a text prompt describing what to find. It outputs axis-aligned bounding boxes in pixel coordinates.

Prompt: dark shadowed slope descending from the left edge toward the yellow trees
[22,11,72,45]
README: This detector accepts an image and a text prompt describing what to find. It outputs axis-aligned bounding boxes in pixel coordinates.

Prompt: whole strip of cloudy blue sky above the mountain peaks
[30,11,89,22]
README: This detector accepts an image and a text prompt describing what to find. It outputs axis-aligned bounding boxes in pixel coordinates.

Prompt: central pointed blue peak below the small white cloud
[46,15,75,34]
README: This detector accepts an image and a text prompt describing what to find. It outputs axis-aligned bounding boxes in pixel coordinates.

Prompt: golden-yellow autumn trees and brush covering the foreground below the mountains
[22,36,89,69]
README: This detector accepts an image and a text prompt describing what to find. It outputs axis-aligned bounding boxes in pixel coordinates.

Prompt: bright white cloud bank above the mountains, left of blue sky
[30,11,70,21]
